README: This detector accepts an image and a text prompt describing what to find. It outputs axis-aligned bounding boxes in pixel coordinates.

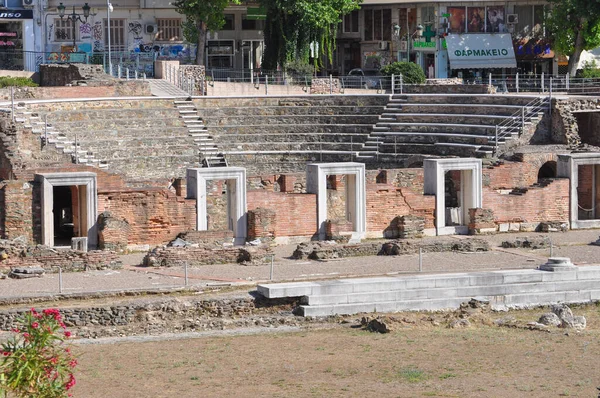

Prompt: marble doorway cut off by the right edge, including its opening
[556,152,600,229]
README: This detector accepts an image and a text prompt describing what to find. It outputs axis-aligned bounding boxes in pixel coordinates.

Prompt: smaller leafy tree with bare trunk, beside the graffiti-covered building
[174,0,239,65]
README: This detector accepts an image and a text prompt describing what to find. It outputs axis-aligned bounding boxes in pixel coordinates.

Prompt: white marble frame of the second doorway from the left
[187,167,248,245]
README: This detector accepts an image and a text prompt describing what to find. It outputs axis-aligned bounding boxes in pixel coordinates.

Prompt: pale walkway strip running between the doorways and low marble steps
[0,230,600,301]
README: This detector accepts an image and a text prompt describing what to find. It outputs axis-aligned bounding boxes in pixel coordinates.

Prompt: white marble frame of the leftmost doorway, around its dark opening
[35,172,98,249]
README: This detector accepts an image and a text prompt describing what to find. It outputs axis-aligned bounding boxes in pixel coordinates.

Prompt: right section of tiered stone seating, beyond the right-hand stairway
[359,94,547,160]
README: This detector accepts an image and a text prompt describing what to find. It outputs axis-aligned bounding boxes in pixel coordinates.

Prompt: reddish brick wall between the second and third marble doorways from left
[247,190,317,237]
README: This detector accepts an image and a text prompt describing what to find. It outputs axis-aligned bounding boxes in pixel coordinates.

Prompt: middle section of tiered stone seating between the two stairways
[198,96,387,173]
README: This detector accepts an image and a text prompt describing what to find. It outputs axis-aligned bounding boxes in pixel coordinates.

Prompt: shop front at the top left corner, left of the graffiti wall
[0,9,35,71]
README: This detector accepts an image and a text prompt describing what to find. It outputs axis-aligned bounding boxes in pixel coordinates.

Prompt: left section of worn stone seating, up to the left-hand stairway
[16,99,200,180]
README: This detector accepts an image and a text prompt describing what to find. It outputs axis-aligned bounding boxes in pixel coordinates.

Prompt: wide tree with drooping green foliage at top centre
[260,0,362,69]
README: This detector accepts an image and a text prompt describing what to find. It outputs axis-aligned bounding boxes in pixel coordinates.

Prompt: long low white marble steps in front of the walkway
[257,264,600,316]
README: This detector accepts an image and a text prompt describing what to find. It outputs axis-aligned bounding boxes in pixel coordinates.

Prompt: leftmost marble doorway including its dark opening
[35,172,98,248]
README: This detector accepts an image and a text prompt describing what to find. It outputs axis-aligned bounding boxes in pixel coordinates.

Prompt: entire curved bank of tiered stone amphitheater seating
[12,94,544,180]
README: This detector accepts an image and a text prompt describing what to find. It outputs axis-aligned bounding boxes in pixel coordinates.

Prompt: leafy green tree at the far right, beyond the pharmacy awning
[548,0,600,76]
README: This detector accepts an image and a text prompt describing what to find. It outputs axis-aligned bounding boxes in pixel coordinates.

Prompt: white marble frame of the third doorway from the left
[306,162,367,242]
